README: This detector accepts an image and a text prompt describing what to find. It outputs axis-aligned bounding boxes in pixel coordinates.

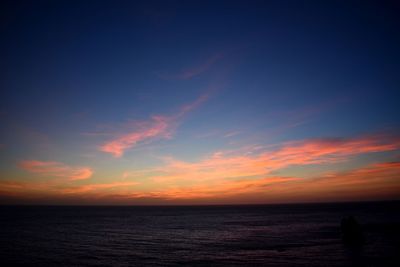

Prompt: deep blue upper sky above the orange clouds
[0,1,400,204]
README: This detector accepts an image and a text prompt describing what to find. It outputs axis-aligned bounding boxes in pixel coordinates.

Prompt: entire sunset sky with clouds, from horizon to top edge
[0,0,400,205]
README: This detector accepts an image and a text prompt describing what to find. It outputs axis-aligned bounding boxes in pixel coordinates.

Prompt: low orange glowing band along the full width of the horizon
[0,162,400,204]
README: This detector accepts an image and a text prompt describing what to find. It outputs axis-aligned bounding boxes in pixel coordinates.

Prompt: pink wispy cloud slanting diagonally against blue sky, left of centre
[99,93,209,157]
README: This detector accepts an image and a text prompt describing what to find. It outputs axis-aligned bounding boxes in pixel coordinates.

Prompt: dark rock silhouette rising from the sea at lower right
[340,216,364,246]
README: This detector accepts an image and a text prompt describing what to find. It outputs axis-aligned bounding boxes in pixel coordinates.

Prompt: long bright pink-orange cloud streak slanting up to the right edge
[149,136,400,183]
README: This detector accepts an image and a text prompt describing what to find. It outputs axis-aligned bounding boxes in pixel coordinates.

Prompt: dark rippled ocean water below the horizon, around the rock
[0,202,400,267]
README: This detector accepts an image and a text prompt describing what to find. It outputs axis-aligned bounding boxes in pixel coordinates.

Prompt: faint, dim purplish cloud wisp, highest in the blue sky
[158,53,224,80]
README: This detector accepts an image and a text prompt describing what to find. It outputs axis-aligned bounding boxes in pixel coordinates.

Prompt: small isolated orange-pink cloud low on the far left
[18,160,93,180]
